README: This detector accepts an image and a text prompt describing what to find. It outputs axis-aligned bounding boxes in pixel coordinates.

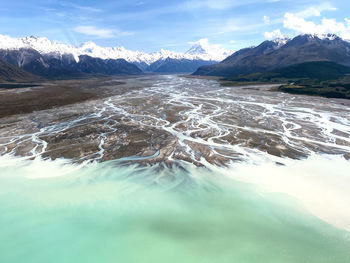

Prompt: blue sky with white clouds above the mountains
[0,0,350,52]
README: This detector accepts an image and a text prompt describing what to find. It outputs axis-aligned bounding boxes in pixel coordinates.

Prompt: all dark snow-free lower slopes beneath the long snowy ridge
[0,49,216,78]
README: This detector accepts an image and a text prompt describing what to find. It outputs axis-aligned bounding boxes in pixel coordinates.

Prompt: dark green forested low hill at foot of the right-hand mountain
[222,61,350,99]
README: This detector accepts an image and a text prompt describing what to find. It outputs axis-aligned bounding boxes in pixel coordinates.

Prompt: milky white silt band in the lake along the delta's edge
[0,154,350,234]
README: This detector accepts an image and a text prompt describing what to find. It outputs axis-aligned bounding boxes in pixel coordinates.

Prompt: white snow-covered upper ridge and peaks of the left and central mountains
[0,34,233,65]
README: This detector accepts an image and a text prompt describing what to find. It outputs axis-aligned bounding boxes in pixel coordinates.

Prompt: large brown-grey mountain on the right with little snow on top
[194,35,350,76]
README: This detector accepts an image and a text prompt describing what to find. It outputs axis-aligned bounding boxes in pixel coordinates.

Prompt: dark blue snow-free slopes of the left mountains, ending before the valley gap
[0,49,142,78]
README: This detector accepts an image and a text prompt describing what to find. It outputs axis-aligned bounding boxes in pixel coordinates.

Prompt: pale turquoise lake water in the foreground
[0,158,350,263]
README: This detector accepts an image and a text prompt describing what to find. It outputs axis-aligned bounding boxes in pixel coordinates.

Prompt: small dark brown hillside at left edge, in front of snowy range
[0,59,39,82]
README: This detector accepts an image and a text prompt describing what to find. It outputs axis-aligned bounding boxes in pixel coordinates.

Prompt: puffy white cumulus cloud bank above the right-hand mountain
[283,13,350,40]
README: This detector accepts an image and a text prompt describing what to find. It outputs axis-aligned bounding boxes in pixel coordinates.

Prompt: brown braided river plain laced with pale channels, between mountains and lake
[0,76,350,166]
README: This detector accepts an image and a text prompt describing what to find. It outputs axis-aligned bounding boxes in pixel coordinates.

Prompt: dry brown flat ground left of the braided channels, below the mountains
[0,76,149,118]
